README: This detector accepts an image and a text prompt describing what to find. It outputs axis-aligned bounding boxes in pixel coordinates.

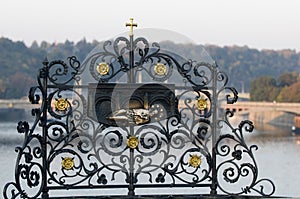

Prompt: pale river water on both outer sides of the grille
[0,122,300,198]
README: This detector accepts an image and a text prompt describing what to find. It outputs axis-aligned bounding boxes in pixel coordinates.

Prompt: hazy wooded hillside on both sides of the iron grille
[0,37,300,101]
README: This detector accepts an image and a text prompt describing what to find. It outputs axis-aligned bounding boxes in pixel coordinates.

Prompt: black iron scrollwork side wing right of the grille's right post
[216,111,275,196]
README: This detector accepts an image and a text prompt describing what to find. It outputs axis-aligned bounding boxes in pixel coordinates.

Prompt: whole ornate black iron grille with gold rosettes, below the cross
[4,33,275,198]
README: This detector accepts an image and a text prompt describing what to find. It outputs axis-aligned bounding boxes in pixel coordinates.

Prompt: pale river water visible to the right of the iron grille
[246,120,300,197]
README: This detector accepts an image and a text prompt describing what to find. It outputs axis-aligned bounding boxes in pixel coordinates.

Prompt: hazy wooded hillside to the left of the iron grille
[0,38,98,98]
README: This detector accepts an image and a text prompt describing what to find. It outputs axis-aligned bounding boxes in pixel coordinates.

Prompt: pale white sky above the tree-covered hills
[0,0,300,52]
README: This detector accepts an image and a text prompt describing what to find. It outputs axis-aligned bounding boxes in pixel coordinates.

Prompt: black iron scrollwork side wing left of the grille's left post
[4,122,45,198]
